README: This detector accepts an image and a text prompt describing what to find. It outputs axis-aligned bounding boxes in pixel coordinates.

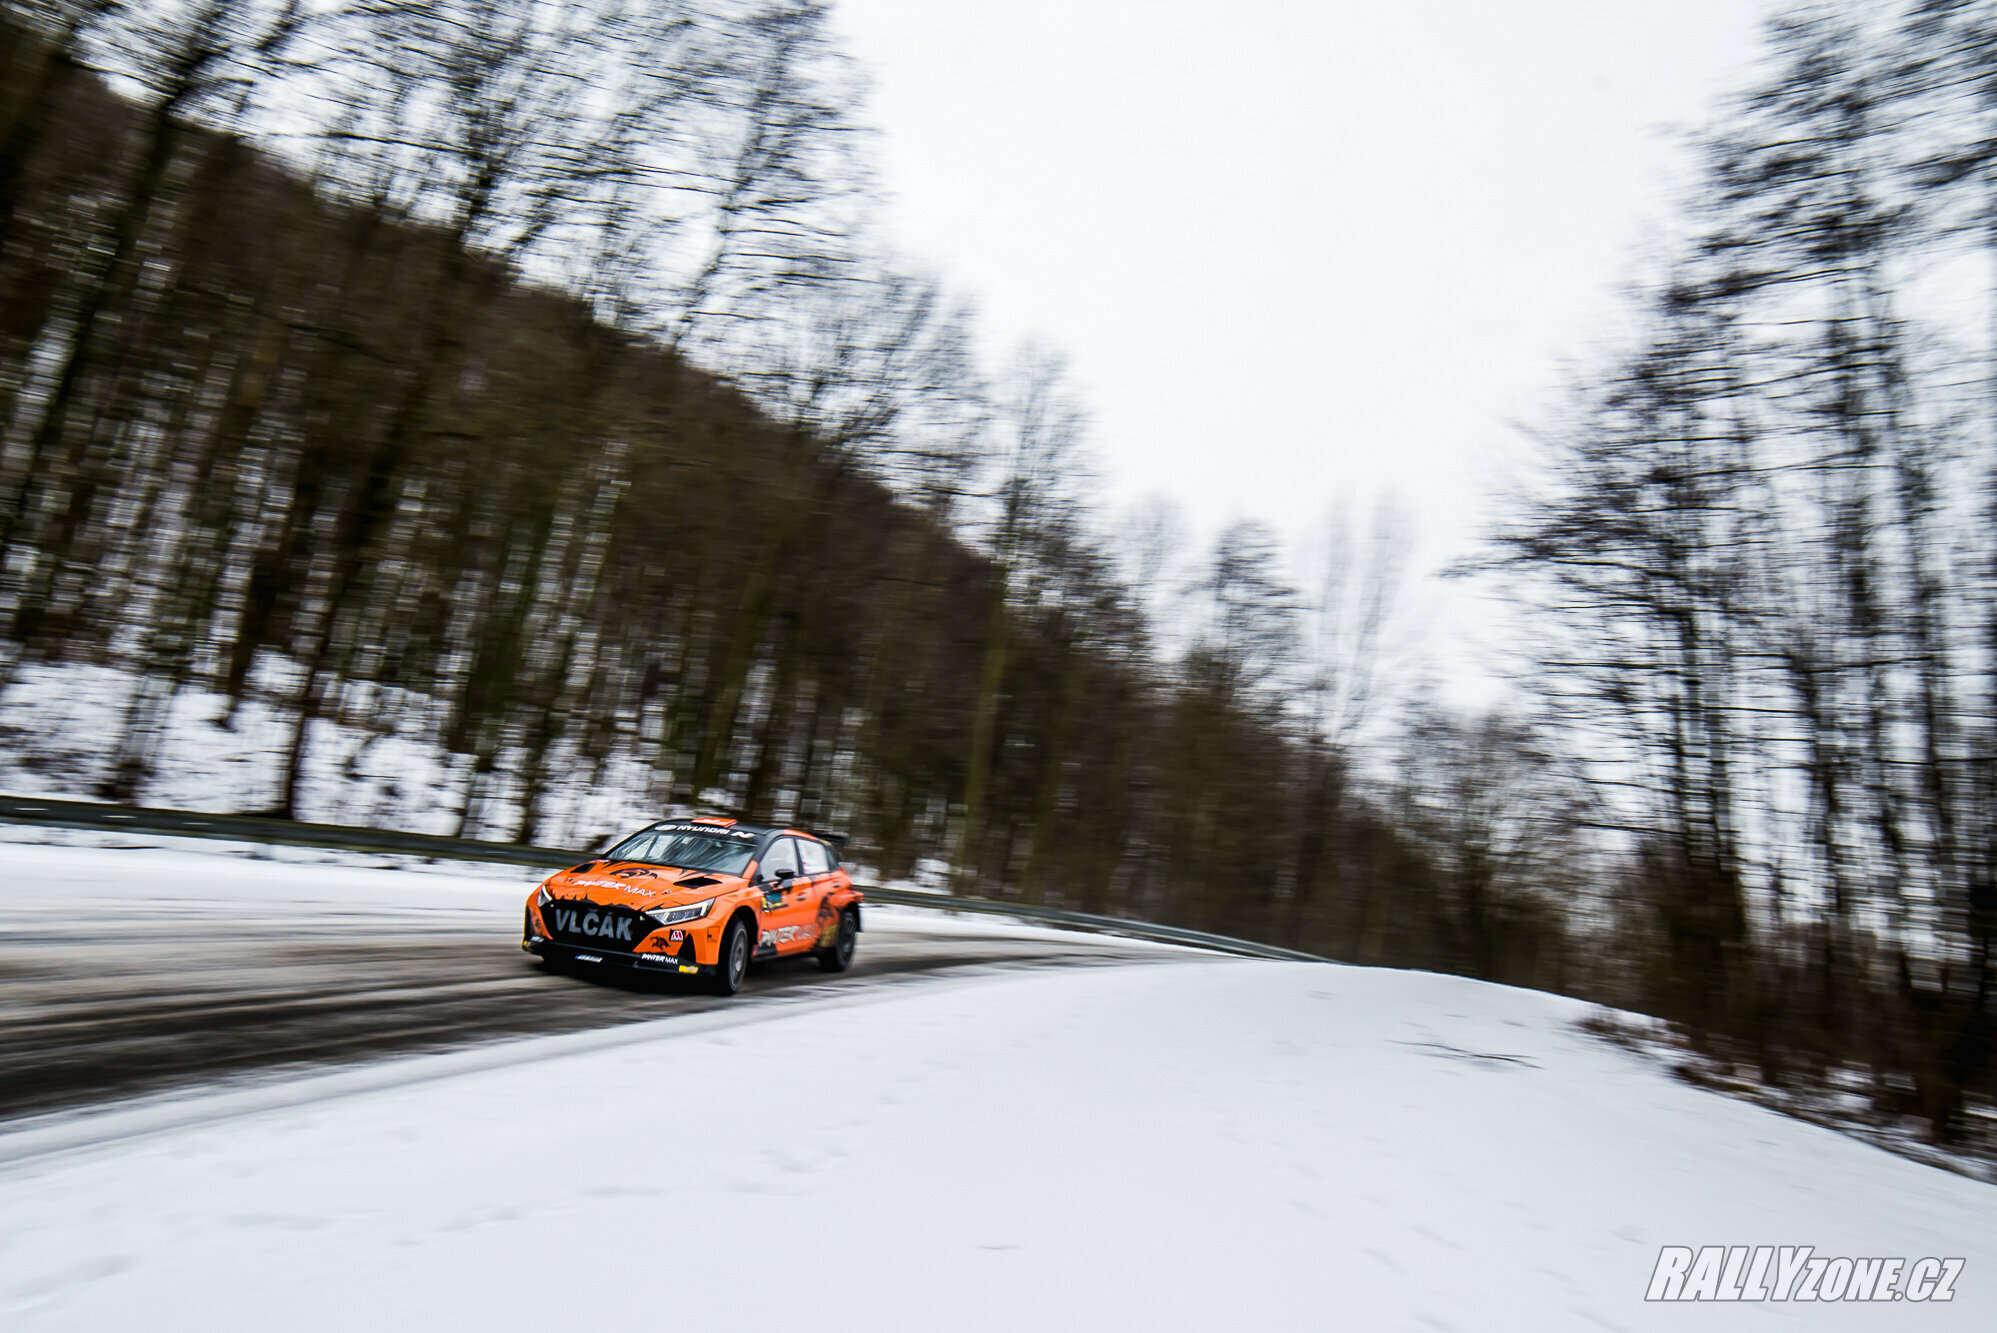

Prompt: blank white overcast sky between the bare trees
[837,0,1763,678]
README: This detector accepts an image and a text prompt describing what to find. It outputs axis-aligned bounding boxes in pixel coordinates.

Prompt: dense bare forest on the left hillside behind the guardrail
[0,0,1582,986]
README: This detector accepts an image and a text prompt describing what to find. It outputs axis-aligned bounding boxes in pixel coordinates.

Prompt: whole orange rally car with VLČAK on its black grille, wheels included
[519,818,861,996]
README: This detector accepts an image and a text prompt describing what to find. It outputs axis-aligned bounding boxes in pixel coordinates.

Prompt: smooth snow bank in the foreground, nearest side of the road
[0,945,1997,1333]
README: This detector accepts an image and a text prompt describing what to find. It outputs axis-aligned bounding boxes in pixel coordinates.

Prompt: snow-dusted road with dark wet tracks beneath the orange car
[0,842,1186,1117]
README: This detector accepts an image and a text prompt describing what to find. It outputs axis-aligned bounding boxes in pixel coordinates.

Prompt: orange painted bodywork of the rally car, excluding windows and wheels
[521,820,863,974]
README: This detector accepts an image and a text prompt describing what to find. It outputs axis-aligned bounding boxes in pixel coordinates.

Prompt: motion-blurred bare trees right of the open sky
[1502,4,1997,1139]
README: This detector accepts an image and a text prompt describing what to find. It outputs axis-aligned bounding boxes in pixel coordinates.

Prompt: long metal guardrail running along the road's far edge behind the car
[0,796,1330,962]
